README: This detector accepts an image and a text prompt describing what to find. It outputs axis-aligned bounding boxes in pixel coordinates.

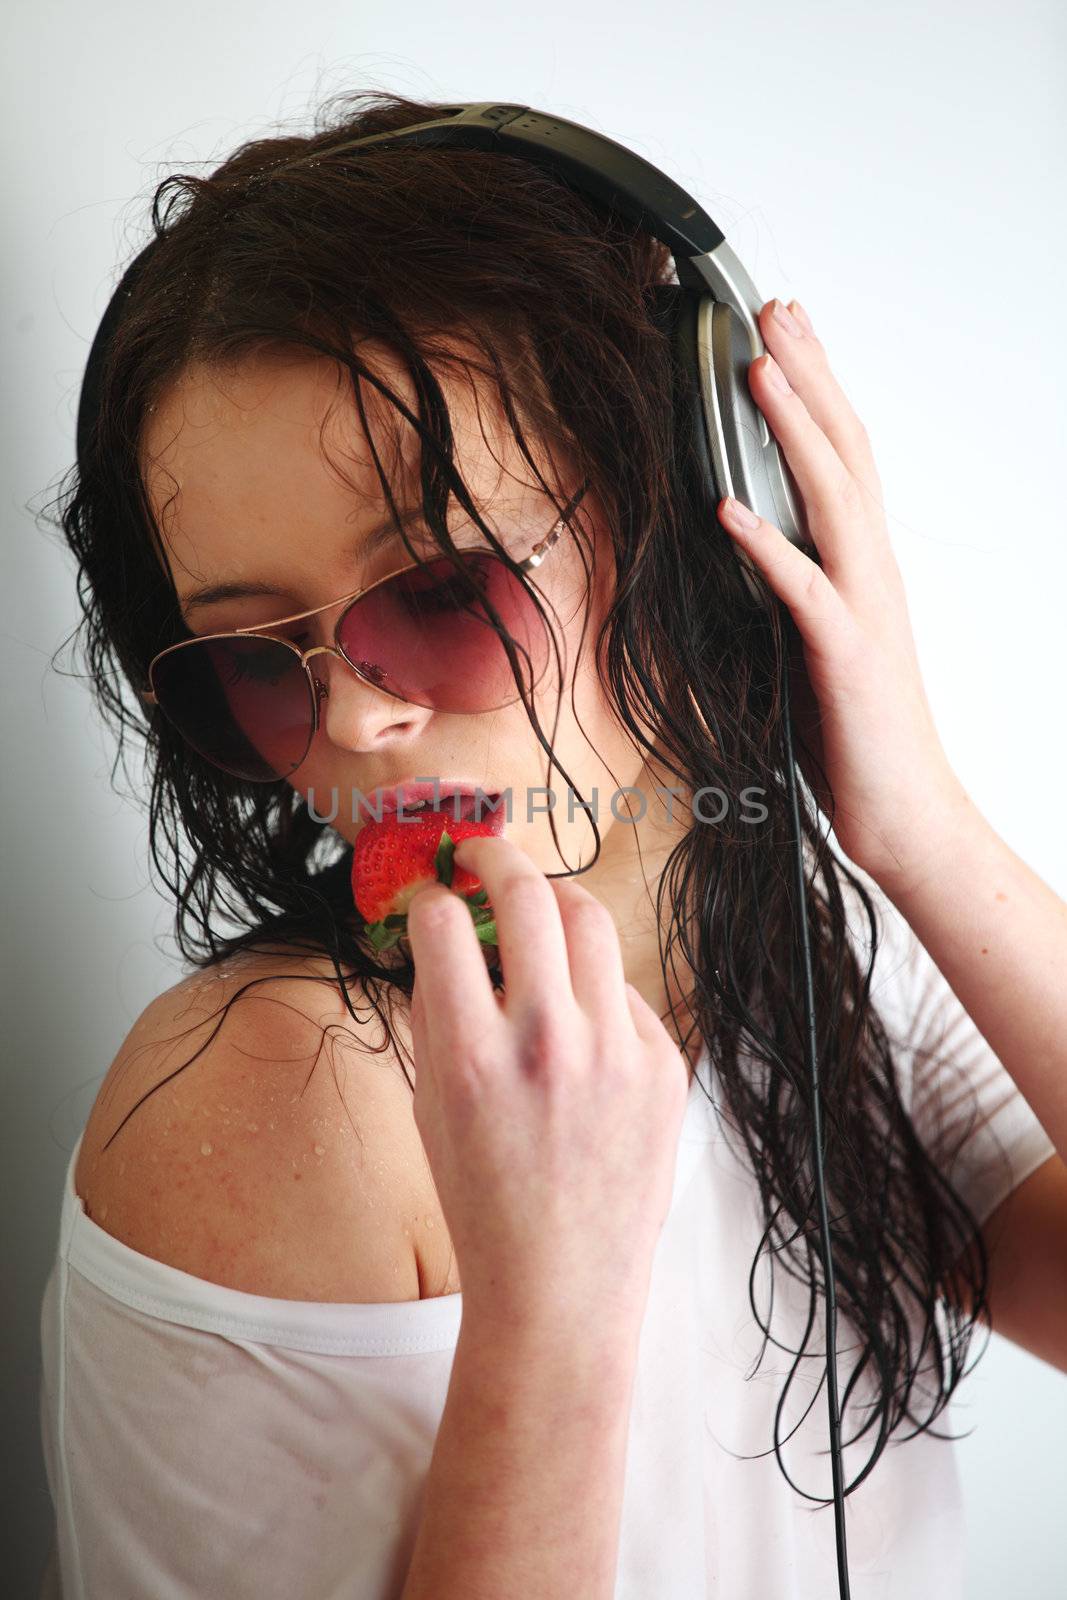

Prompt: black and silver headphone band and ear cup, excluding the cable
[77,101,809,603]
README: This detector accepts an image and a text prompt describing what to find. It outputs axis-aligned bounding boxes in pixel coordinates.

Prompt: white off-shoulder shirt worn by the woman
[40,883,1054,1600]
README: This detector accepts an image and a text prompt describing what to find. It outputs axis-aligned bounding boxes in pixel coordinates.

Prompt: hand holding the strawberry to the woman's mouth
[396,837,689,1344]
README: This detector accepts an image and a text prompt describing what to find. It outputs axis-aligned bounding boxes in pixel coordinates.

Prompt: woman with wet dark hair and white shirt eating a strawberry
[43,96,1067,1600]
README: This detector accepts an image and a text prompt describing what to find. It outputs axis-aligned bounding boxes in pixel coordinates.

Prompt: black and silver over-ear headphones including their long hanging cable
[77,101,849,1600]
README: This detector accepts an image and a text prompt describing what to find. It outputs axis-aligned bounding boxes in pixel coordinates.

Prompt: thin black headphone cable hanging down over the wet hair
[781,606,849,1600]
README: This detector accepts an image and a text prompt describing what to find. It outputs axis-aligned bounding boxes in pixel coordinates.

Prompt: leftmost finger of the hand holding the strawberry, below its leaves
[408,883,498,1051]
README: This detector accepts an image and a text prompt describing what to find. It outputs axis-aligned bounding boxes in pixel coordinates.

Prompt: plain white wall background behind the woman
[0,0,1067,1600]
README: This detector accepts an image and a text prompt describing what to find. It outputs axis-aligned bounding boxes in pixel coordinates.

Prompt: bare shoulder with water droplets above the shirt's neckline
[75,955,457,1304]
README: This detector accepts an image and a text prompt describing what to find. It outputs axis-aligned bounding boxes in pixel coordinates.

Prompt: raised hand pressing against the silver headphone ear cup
[718,299,974,890]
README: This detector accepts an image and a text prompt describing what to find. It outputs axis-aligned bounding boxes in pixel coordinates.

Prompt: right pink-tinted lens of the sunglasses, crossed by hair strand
[339,552,549,712]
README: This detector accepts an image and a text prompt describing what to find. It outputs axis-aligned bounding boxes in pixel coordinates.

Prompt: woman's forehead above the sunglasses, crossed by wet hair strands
[141,339,517,592]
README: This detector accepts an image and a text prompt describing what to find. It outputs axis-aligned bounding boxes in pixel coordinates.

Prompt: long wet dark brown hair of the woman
[41,93,989,1499]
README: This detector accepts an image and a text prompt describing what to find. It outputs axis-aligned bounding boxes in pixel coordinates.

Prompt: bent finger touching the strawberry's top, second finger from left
[453,834,573,1014]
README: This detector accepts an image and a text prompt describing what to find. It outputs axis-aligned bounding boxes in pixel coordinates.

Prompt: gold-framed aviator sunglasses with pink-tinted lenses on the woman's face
[139,483,589,784]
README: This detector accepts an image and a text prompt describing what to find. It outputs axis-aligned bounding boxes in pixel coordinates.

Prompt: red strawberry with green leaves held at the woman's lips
[352,811,502,950]
